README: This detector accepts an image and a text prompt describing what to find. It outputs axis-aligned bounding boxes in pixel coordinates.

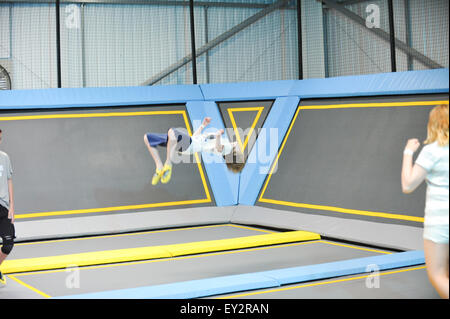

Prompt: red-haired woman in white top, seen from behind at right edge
[402,104,449,299]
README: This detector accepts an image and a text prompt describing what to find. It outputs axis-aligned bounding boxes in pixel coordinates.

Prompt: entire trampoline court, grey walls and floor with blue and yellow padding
[0,70,448,300]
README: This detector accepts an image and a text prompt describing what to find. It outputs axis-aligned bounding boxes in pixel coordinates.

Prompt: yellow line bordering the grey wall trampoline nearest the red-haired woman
[259,101,449,223]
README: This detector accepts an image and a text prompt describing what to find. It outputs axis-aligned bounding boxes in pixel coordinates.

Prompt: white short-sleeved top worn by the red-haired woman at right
[416,142,449,225]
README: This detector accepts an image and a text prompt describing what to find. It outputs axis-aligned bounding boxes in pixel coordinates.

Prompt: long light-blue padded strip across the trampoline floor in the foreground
[55,251,425,299]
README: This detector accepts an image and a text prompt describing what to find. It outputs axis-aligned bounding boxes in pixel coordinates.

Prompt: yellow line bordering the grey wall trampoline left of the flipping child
[7,110,212,219]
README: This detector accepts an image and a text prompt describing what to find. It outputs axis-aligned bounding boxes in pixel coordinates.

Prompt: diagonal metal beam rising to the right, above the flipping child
[141,0,289,85]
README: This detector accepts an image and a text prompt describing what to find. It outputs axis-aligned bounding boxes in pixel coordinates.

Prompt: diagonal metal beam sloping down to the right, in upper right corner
[319,0,443,69]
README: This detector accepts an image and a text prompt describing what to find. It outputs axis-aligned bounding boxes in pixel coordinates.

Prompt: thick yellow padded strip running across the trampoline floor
[2,231,320,274]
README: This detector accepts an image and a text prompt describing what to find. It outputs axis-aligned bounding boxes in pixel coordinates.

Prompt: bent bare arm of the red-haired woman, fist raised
[402,139,427,194]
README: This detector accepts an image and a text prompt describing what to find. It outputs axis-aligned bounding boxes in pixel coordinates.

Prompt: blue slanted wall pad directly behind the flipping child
[186,101,239,206]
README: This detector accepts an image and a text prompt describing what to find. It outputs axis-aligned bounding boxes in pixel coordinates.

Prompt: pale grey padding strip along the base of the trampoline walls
[12,205,423,250]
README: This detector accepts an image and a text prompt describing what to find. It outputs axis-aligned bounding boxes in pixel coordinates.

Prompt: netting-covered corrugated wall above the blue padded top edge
[0,0,449,89]
